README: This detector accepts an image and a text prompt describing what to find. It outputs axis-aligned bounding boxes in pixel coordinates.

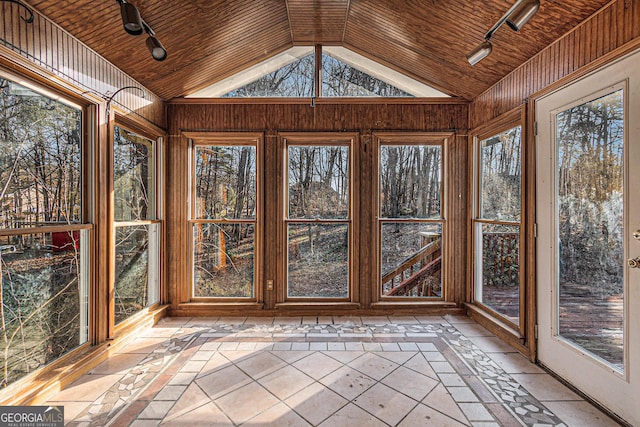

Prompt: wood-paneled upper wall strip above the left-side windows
[0,2,166,127]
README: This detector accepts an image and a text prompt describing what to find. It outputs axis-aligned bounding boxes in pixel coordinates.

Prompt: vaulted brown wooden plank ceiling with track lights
[27,0,609,100]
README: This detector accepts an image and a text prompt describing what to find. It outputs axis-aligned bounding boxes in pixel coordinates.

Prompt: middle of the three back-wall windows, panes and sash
[283,134,355,300]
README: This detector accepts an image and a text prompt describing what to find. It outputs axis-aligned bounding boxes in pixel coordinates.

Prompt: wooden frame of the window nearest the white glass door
[468,106,528,340]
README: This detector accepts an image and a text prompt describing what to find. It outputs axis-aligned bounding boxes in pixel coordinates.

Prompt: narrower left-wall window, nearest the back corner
[113,126,160,324]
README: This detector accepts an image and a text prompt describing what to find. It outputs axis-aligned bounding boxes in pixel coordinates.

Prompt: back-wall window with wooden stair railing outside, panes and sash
[376,134,445,299]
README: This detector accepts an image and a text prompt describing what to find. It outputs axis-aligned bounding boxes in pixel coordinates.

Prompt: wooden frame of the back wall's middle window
[276,132,360,307]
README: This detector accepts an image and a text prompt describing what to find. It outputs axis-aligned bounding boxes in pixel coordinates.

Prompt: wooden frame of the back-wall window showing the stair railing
[371,132,455,305]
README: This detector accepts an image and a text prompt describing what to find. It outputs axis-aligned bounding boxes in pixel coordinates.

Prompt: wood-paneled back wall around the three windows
[166,100,468,313]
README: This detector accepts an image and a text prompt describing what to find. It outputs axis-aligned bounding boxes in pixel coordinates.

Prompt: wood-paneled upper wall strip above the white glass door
[469,0,640,129]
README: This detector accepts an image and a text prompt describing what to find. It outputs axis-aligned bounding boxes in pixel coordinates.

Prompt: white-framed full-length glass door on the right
[536,49,640,425]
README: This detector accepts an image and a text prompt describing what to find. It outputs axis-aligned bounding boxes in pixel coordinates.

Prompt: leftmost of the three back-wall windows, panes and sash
[191,134,261,300]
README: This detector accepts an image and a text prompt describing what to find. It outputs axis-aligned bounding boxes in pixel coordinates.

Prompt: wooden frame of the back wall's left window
[183,132,264,306]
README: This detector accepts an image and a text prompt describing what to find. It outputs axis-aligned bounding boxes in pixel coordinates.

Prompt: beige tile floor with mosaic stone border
[47,316,617,427]
